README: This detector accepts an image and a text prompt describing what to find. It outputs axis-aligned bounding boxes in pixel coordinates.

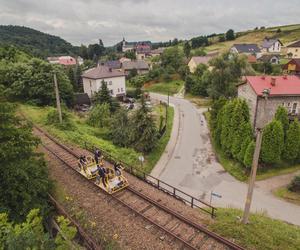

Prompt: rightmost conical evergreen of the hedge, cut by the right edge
[277,119,300,162]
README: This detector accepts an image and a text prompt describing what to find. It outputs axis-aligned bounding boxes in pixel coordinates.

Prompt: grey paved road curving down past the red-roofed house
[151,94,300,225]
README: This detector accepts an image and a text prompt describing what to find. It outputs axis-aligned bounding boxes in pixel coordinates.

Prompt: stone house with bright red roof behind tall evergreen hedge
[238,76,300,128]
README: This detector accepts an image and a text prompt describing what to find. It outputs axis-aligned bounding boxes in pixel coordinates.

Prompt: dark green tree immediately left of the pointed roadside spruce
[110,108,131,147]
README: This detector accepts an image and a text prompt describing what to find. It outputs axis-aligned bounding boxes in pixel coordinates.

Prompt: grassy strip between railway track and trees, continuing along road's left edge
[19,105,174,172]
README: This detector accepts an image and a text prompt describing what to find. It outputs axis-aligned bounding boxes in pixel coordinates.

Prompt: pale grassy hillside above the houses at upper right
[205,24,300,52]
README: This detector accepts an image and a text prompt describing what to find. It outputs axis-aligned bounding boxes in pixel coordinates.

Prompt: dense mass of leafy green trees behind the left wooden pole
[0,46,73,106]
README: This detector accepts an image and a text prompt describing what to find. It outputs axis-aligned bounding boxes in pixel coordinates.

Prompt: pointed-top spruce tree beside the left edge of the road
[131,98,158,153]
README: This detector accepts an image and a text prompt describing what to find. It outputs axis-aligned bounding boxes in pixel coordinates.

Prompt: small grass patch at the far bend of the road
[143,80,183,95]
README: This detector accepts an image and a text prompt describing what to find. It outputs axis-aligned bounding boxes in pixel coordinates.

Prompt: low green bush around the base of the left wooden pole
[46,108,75,130]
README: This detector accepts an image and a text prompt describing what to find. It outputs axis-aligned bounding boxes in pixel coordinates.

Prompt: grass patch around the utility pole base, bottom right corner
[208,208,300,250]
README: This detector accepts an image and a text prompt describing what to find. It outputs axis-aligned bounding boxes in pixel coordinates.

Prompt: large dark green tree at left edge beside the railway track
[0,102,51,220]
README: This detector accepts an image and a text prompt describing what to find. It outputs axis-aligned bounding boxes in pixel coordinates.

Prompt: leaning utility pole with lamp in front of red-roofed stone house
[242,89,270,224]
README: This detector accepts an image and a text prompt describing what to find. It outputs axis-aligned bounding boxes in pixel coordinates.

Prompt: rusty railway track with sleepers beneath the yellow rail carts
[35,126,243,250]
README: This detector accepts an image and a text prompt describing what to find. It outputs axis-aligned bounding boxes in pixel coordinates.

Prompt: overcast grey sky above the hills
[0,0,300,45]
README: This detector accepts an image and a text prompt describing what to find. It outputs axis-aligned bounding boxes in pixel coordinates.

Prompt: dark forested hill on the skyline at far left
[0,25,75,57]
